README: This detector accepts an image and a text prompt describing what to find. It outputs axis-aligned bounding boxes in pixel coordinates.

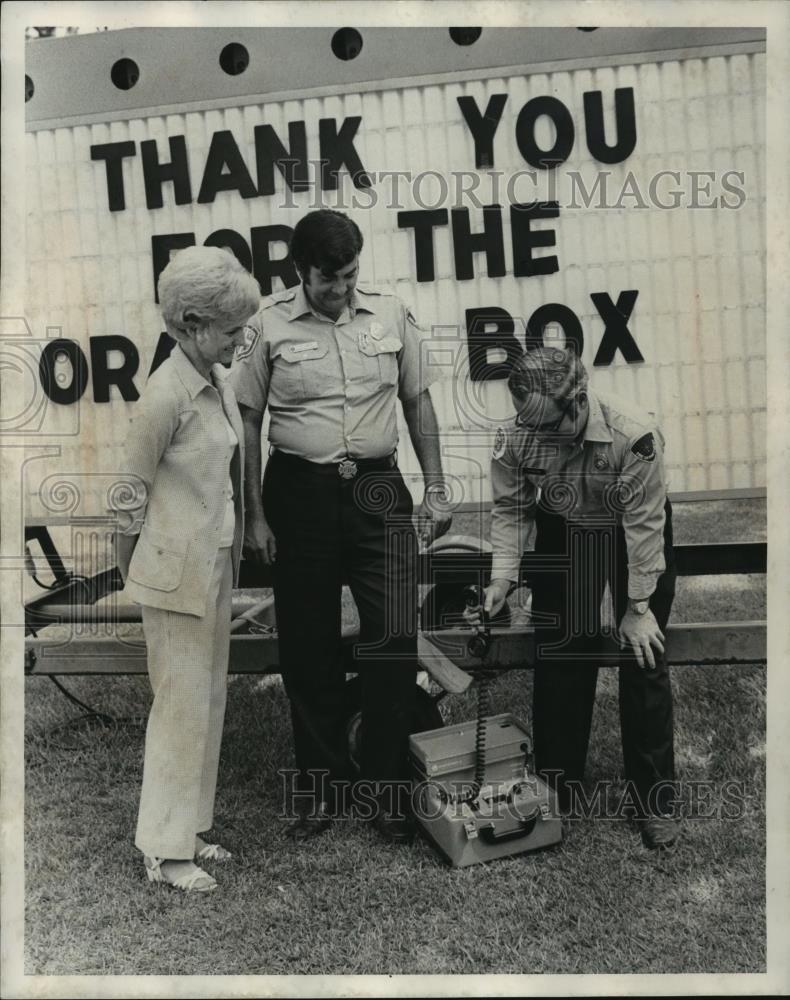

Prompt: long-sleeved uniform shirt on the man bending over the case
[491,390,667,600]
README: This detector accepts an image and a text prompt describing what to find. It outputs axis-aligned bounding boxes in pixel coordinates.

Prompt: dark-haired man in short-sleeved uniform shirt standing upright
[231,210,450,840]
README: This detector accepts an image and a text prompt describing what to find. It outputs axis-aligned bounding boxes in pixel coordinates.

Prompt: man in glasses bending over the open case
[467,347,677,848]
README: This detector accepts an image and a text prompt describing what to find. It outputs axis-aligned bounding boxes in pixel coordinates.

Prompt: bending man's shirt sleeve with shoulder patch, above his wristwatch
[620,433,667,600]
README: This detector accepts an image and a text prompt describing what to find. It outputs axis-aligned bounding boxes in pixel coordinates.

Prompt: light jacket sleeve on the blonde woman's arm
[110,386,178,535]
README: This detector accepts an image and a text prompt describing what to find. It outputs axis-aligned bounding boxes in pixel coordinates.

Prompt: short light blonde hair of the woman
[158,247,261,340]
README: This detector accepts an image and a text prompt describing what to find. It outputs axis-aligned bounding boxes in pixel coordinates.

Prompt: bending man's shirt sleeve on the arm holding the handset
[491,432,535,583]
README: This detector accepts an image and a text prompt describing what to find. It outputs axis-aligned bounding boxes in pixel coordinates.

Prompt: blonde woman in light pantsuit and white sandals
[117,247,260,892]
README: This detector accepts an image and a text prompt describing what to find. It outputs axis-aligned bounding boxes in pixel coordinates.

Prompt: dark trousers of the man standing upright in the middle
[263,452,418,808]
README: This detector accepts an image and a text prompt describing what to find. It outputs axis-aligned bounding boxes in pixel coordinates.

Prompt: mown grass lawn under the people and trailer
[25,505,765,975]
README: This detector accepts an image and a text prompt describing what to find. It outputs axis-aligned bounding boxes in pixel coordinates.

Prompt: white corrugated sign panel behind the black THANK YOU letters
[26,46,766,516]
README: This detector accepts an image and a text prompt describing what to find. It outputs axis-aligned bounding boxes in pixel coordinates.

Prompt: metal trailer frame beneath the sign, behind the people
[25,526,767,676]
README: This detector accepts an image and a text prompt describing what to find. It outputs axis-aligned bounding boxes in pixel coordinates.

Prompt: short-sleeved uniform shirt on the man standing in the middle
[230,285,435,463]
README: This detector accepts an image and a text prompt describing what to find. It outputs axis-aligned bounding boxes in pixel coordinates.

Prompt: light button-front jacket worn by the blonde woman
[116,345,244,616]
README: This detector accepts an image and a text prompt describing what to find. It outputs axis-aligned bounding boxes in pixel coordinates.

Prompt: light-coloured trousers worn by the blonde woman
[135,548,233,860]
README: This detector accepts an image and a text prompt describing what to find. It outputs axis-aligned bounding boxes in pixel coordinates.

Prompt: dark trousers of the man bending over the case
[532,501,676,815]
